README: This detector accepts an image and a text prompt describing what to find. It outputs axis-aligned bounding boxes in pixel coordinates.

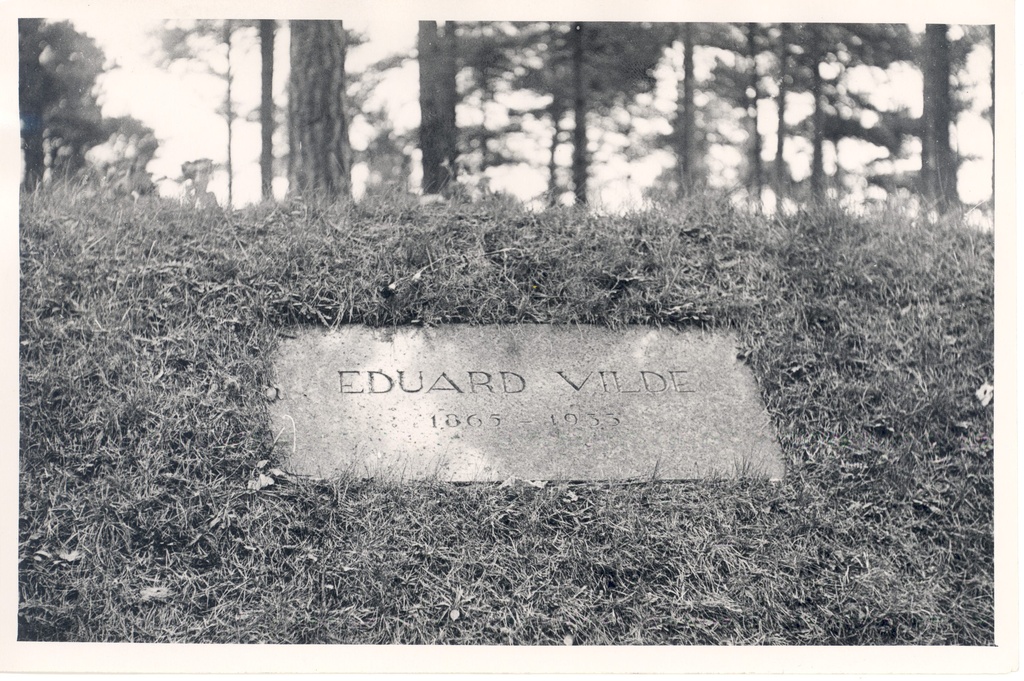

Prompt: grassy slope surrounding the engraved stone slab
[18,186,993,645]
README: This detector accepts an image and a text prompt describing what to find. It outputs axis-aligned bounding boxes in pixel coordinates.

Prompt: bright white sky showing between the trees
[64,15,992,210]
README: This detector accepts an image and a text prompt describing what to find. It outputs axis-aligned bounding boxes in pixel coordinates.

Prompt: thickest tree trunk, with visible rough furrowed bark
[288,20,351,199]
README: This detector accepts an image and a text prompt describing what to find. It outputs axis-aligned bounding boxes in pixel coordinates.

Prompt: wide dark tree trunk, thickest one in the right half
[922,24,958,211]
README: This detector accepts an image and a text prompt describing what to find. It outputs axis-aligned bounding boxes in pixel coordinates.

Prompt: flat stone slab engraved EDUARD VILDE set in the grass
[270,325,783,481]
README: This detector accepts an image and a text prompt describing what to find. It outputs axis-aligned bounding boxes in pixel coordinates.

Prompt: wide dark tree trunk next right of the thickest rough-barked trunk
[417,22,460,194]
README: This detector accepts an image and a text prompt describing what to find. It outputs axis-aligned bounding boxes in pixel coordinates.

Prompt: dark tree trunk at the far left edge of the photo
[17,18,46,191]
